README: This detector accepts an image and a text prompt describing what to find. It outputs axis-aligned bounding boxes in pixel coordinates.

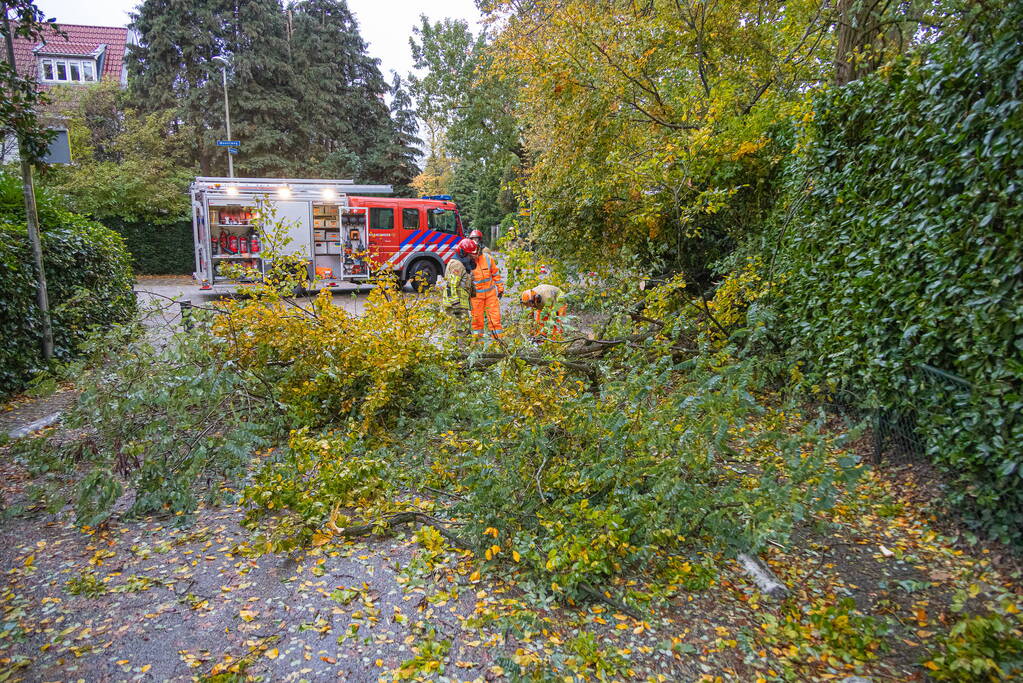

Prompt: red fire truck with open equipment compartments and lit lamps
[191,178,462,289]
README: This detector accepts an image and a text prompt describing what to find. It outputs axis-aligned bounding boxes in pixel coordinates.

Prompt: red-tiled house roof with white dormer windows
[14,24,131,90]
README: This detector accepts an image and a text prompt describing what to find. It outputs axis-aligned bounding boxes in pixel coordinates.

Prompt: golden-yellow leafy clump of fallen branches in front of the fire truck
[215,283,447,431]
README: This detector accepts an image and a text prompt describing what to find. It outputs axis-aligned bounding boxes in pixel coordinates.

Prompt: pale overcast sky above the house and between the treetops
[36,0,480,81]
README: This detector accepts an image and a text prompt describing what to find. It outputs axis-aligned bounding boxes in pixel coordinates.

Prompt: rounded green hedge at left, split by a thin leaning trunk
[0,214,135,395]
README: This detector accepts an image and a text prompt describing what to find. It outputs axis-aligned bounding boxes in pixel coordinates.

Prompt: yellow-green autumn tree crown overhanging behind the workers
[487,0,831,278]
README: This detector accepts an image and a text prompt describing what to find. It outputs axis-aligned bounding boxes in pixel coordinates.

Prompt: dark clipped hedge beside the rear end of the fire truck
[102,218,195,275]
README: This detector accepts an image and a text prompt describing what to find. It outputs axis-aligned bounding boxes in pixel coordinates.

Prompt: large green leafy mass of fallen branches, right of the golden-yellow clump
[448,351,854,597]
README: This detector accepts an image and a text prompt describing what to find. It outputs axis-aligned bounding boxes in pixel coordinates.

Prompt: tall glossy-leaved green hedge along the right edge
[774,3,1023,543]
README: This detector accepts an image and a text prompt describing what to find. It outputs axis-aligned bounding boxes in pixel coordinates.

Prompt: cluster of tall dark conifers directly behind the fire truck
[129,0,417,183]
